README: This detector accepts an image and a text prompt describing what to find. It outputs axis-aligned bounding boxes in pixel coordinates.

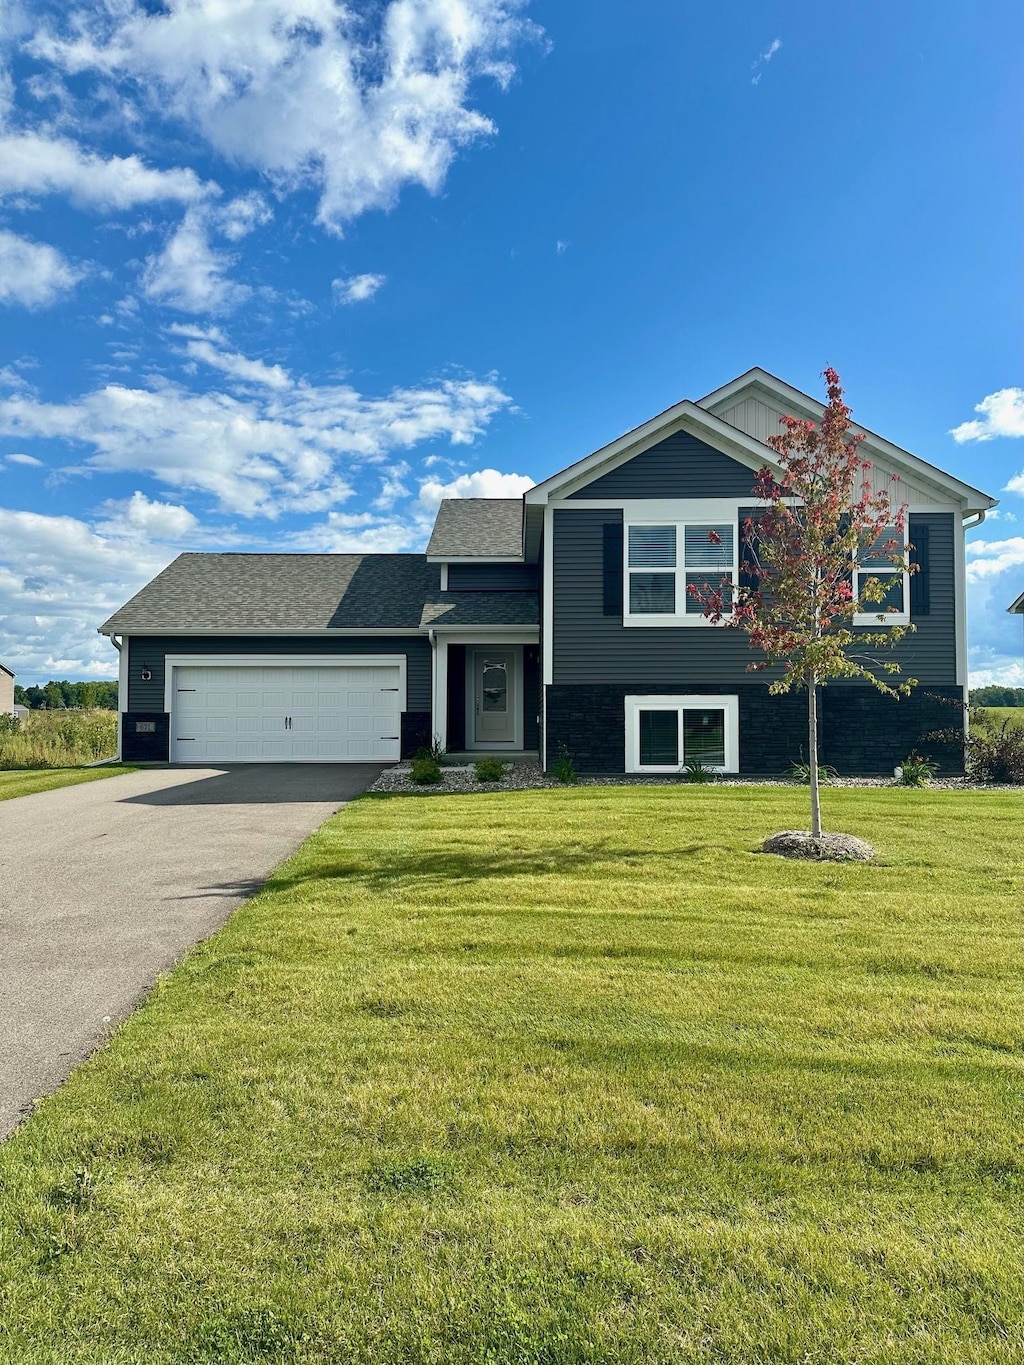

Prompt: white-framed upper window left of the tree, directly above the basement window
[623,520,739,625]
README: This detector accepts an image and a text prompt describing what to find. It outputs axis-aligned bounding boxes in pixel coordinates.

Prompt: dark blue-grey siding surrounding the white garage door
[126,635,430,713]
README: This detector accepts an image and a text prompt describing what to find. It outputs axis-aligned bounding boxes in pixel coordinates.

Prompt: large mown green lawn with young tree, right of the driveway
[0,788,1024,1365]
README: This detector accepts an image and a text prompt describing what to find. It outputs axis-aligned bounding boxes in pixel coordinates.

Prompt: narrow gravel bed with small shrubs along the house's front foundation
[369,763,1017,796]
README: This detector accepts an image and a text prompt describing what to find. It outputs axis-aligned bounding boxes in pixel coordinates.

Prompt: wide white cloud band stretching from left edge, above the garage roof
[0,368,513,517]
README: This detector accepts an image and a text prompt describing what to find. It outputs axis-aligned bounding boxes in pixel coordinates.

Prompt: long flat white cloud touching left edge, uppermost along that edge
[0,132,212,209]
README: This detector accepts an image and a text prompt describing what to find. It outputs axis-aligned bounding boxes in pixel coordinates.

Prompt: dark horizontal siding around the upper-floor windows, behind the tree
[552,508,957,691]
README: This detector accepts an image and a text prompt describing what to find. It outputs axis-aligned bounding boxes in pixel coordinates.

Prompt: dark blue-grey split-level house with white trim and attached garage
[101,370,995,774]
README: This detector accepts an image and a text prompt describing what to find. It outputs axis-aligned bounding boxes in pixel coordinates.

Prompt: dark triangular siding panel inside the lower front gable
[569,431,769,502]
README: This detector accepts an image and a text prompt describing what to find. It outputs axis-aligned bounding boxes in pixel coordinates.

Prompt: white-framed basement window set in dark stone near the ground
[625,693,740,773]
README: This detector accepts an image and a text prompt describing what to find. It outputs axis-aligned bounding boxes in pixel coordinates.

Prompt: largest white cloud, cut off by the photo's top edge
[29,0,538,231]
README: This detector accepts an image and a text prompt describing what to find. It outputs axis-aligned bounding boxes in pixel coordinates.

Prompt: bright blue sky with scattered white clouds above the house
[0,0,1024,684]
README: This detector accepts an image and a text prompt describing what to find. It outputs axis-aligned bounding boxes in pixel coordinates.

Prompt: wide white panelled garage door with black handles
[171,663,401,763]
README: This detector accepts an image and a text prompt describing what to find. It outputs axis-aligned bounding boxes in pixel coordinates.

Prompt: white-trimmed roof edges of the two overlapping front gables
[524,367,998,513]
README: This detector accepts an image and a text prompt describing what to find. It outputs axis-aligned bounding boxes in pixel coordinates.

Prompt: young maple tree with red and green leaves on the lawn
[688,369,916,838]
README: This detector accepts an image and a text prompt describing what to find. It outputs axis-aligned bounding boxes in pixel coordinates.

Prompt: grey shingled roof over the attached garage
[100,554,440,635]
